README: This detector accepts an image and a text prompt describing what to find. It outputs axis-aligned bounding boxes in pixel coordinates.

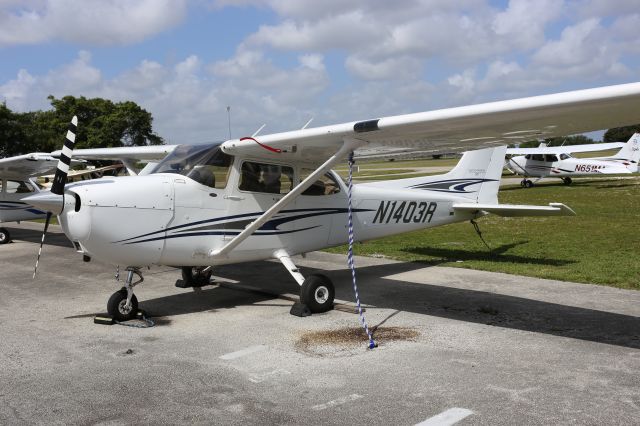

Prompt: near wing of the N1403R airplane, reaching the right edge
[222,83,640,164]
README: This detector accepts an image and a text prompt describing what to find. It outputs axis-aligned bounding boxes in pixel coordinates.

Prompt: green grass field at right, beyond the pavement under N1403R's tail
[329,177,640,289]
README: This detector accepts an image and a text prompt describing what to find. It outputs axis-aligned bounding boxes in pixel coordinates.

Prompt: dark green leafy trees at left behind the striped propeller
[0,96,164,158]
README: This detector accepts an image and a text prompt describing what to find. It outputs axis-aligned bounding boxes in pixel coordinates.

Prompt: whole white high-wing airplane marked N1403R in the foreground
[26,83,640,320]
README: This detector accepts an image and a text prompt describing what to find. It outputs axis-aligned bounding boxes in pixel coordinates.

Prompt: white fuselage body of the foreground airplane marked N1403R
[59,146,474,266]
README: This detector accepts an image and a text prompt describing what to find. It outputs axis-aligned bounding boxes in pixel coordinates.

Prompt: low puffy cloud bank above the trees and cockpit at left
[0,50,328,143]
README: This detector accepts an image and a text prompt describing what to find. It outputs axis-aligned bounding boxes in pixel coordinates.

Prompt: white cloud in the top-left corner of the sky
[0,0,186,47]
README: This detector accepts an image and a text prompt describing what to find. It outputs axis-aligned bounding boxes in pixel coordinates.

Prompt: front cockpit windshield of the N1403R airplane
[151,142,233,188]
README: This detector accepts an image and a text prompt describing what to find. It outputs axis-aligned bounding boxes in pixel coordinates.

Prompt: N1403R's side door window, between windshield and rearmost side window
[239,161,293,194]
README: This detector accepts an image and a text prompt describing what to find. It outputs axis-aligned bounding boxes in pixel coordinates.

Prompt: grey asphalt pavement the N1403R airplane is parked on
[0,223,640,425]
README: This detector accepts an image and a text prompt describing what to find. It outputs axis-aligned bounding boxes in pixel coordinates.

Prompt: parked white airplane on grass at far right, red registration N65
[505,133,640,188]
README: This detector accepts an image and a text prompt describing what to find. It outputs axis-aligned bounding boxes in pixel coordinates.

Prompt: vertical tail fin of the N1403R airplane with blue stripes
[364,146,507,204]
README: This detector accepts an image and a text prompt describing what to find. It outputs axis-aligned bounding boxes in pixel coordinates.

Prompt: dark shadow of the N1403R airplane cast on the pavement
[141,262,640,349]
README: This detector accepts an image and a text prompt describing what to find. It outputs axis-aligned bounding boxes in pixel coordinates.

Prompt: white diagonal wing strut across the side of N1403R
[209,138,367,257]
